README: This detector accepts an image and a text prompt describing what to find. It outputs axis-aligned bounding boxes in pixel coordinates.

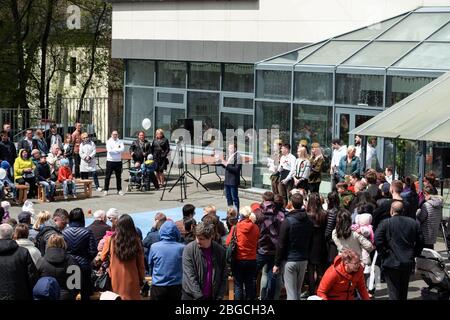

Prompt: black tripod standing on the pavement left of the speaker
[161,137,208,202]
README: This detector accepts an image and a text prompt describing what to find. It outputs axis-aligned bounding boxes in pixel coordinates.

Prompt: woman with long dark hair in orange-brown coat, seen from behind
[102,214,145,300]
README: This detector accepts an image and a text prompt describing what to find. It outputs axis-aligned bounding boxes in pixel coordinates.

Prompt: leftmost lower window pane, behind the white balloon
[124,87,153,138]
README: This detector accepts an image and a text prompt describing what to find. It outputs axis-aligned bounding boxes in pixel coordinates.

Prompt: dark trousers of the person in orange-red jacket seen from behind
[231,260,256,300]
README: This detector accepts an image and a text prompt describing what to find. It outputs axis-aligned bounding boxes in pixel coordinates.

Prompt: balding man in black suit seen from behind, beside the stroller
[375,201,424,300]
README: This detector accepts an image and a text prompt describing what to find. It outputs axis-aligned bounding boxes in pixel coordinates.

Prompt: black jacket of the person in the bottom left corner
[0,240,37,300]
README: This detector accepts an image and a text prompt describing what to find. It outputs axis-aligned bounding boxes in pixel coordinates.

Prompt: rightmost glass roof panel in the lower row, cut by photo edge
[394,42,450,69]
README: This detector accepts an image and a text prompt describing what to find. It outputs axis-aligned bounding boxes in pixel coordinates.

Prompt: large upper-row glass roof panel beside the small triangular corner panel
[378,12,450,41]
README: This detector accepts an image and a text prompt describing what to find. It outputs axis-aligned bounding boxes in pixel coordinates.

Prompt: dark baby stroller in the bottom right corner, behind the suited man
[416,248,450,300]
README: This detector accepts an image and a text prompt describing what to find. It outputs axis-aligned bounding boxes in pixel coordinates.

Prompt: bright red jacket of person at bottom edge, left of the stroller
[317,256,370,300]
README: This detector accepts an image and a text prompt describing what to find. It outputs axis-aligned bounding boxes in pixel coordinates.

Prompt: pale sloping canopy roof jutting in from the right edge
[350,72,450,142]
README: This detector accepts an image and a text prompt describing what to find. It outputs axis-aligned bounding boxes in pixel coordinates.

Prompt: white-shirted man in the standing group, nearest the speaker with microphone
[278,143,295,205]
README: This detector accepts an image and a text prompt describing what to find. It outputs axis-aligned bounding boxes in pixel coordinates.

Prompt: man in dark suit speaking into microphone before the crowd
[221,143,242,212]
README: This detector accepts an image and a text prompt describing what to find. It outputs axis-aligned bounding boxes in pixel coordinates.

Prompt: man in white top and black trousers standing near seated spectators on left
[103,130,124,196]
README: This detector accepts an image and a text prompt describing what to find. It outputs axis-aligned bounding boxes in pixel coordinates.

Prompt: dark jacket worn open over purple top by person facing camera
[181,241,227,300]
